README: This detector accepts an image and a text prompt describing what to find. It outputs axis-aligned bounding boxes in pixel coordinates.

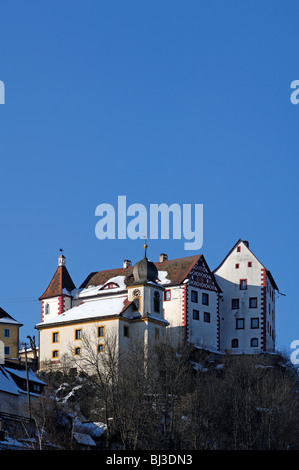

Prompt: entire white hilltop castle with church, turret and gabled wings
[36,240,278,368]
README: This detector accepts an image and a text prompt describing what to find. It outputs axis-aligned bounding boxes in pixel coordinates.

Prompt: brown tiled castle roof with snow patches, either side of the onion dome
[80,255,202,289]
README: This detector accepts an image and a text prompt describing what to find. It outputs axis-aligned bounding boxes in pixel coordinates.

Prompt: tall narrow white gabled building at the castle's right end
[214,239,278,354]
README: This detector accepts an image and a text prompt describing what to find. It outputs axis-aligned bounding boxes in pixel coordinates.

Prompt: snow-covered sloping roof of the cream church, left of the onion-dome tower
[36,295,127,327]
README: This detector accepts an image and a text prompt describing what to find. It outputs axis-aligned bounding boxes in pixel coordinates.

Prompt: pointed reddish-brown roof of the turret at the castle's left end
[39,254,76,300]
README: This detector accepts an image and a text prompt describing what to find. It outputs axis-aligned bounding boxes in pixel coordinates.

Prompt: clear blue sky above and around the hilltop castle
[0,0,299,356]
